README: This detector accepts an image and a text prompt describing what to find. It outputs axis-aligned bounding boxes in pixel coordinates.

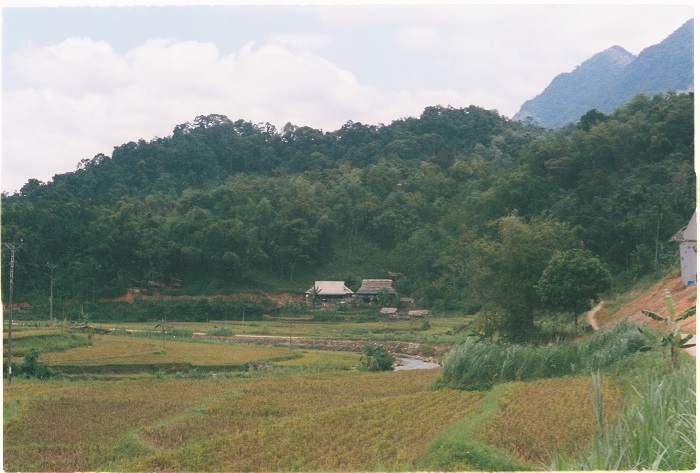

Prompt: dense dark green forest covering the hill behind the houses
[2,93,696,336]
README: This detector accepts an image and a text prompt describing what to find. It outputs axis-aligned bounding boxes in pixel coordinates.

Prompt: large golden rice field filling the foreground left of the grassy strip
[4,370,480,471]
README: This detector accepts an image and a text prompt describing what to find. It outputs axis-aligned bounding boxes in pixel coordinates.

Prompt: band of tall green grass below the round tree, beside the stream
[438,322,646,390]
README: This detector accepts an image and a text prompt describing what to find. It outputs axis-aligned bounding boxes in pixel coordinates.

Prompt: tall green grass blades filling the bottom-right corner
[552,363,696,471]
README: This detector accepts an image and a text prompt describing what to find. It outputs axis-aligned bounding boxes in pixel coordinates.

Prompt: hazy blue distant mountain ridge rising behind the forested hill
[513,19,694,128]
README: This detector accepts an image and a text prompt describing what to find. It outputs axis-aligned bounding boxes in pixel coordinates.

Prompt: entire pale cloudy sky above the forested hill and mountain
[1,0,693,192]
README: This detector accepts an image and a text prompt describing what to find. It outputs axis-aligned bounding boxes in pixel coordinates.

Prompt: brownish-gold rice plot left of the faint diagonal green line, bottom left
[3,379,239,471]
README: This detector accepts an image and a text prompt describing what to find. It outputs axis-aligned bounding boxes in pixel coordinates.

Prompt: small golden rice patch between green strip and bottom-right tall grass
[475,377,623,462]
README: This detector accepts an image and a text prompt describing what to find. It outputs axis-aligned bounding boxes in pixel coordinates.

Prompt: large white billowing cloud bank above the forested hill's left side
[3,38,410,191]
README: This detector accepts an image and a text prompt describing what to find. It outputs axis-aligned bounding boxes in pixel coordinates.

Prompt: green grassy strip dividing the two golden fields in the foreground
[416,383,531,471]
